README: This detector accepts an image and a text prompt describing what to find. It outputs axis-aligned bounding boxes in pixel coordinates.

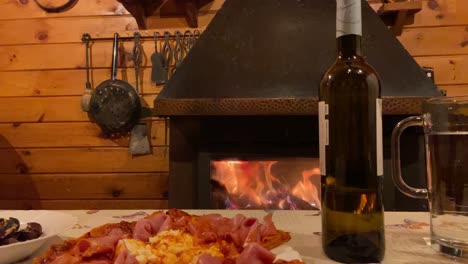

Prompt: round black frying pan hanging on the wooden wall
[88,33,141,135]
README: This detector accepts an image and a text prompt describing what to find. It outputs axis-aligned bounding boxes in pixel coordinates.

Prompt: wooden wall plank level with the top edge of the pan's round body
[0,67,162,97]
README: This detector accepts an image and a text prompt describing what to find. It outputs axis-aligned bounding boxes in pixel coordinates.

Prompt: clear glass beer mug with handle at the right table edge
[392,96,468,258]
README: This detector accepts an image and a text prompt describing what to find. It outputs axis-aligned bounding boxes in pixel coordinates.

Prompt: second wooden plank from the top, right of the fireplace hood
[398,26,468,56]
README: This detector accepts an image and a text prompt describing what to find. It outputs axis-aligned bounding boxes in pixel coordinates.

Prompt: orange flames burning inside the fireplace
[211,160,320,209]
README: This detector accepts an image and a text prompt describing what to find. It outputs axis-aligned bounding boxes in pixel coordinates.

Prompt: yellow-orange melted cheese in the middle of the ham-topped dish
[116,230,223,264]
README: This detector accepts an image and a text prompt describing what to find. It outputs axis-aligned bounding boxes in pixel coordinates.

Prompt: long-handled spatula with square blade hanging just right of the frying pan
[128,32,151,155]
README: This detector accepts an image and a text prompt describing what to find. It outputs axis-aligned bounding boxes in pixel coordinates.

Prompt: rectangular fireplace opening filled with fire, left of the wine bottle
[210,158,320,210]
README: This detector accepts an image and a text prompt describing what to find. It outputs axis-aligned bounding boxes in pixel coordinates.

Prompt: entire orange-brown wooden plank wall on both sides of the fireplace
[0,0,468,209]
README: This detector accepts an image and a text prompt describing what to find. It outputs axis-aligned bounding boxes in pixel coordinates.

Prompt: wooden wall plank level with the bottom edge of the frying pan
[0,120,165,149]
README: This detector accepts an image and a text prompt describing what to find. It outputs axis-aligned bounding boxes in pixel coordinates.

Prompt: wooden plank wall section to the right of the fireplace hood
[399,0,468,95]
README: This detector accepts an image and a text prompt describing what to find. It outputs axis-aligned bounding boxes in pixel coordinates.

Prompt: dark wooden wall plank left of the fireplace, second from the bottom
[0,173,168,199]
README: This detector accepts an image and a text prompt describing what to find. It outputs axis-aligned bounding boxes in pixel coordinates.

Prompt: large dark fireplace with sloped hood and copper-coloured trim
[154,0,441,211]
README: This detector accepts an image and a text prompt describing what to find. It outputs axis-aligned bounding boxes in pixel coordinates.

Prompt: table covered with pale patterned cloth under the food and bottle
[21,210,468,264]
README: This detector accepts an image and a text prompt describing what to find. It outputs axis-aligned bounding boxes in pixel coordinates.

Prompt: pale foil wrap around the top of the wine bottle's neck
[336,0,362,38]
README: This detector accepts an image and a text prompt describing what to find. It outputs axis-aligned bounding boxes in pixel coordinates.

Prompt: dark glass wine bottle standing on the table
[319,0,385,263]
